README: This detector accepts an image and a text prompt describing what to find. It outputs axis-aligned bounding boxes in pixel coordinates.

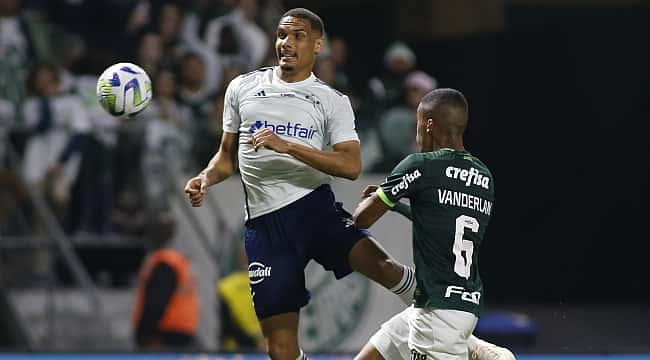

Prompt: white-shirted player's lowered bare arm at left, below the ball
[185,132,239,207]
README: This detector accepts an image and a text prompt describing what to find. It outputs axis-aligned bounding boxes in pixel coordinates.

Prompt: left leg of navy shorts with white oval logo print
[245,216,309,320]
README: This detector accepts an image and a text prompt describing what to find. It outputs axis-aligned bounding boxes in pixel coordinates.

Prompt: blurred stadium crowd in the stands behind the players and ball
[0,0,437,240]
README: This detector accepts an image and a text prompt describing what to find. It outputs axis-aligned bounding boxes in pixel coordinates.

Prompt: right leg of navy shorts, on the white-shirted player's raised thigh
[310,203,368,279]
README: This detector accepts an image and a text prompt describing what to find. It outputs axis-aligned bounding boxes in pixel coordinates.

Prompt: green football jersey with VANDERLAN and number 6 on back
[377,148,494,316]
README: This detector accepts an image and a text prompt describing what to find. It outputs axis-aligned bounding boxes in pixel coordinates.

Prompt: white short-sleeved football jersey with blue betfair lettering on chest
[223,67,359,219]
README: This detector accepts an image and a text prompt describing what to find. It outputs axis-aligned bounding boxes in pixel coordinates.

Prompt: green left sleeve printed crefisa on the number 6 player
[377,155,424,208]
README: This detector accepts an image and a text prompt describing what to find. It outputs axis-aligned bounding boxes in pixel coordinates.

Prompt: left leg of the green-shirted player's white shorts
[368,306,413,360]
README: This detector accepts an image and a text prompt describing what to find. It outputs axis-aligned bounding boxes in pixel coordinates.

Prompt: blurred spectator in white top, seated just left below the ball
[23,64,91,214]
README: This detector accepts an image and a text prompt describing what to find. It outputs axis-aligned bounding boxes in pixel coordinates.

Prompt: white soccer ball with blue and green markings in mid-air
[97,63,153,118]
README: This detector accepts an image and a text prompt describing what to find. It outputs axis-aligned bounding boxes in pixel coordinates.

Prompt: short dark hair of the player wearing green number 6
[419,88,468,134]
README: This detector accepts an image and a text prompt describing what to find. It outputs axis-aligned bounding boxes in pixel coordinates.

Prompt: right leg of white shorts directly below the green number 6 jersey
[408,308,478,360]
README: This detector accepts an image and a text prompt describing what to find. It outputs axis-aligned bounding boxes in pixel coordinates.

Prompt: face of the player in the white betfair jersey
[275,16,323,73]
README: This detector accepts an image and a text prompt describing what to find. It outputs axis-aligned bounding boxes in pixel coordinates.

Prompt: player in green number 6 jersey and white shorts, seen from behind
[354,89,514,360]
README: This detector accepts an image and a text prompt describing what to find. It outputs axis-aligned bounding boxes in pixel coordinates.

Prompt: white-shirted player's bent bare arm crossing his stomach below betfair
[248,129,361,180]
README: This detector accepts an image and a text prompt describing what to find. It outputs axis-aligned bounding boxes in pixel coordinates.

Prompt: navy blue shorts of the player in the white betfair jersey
[245,185,368,319]
